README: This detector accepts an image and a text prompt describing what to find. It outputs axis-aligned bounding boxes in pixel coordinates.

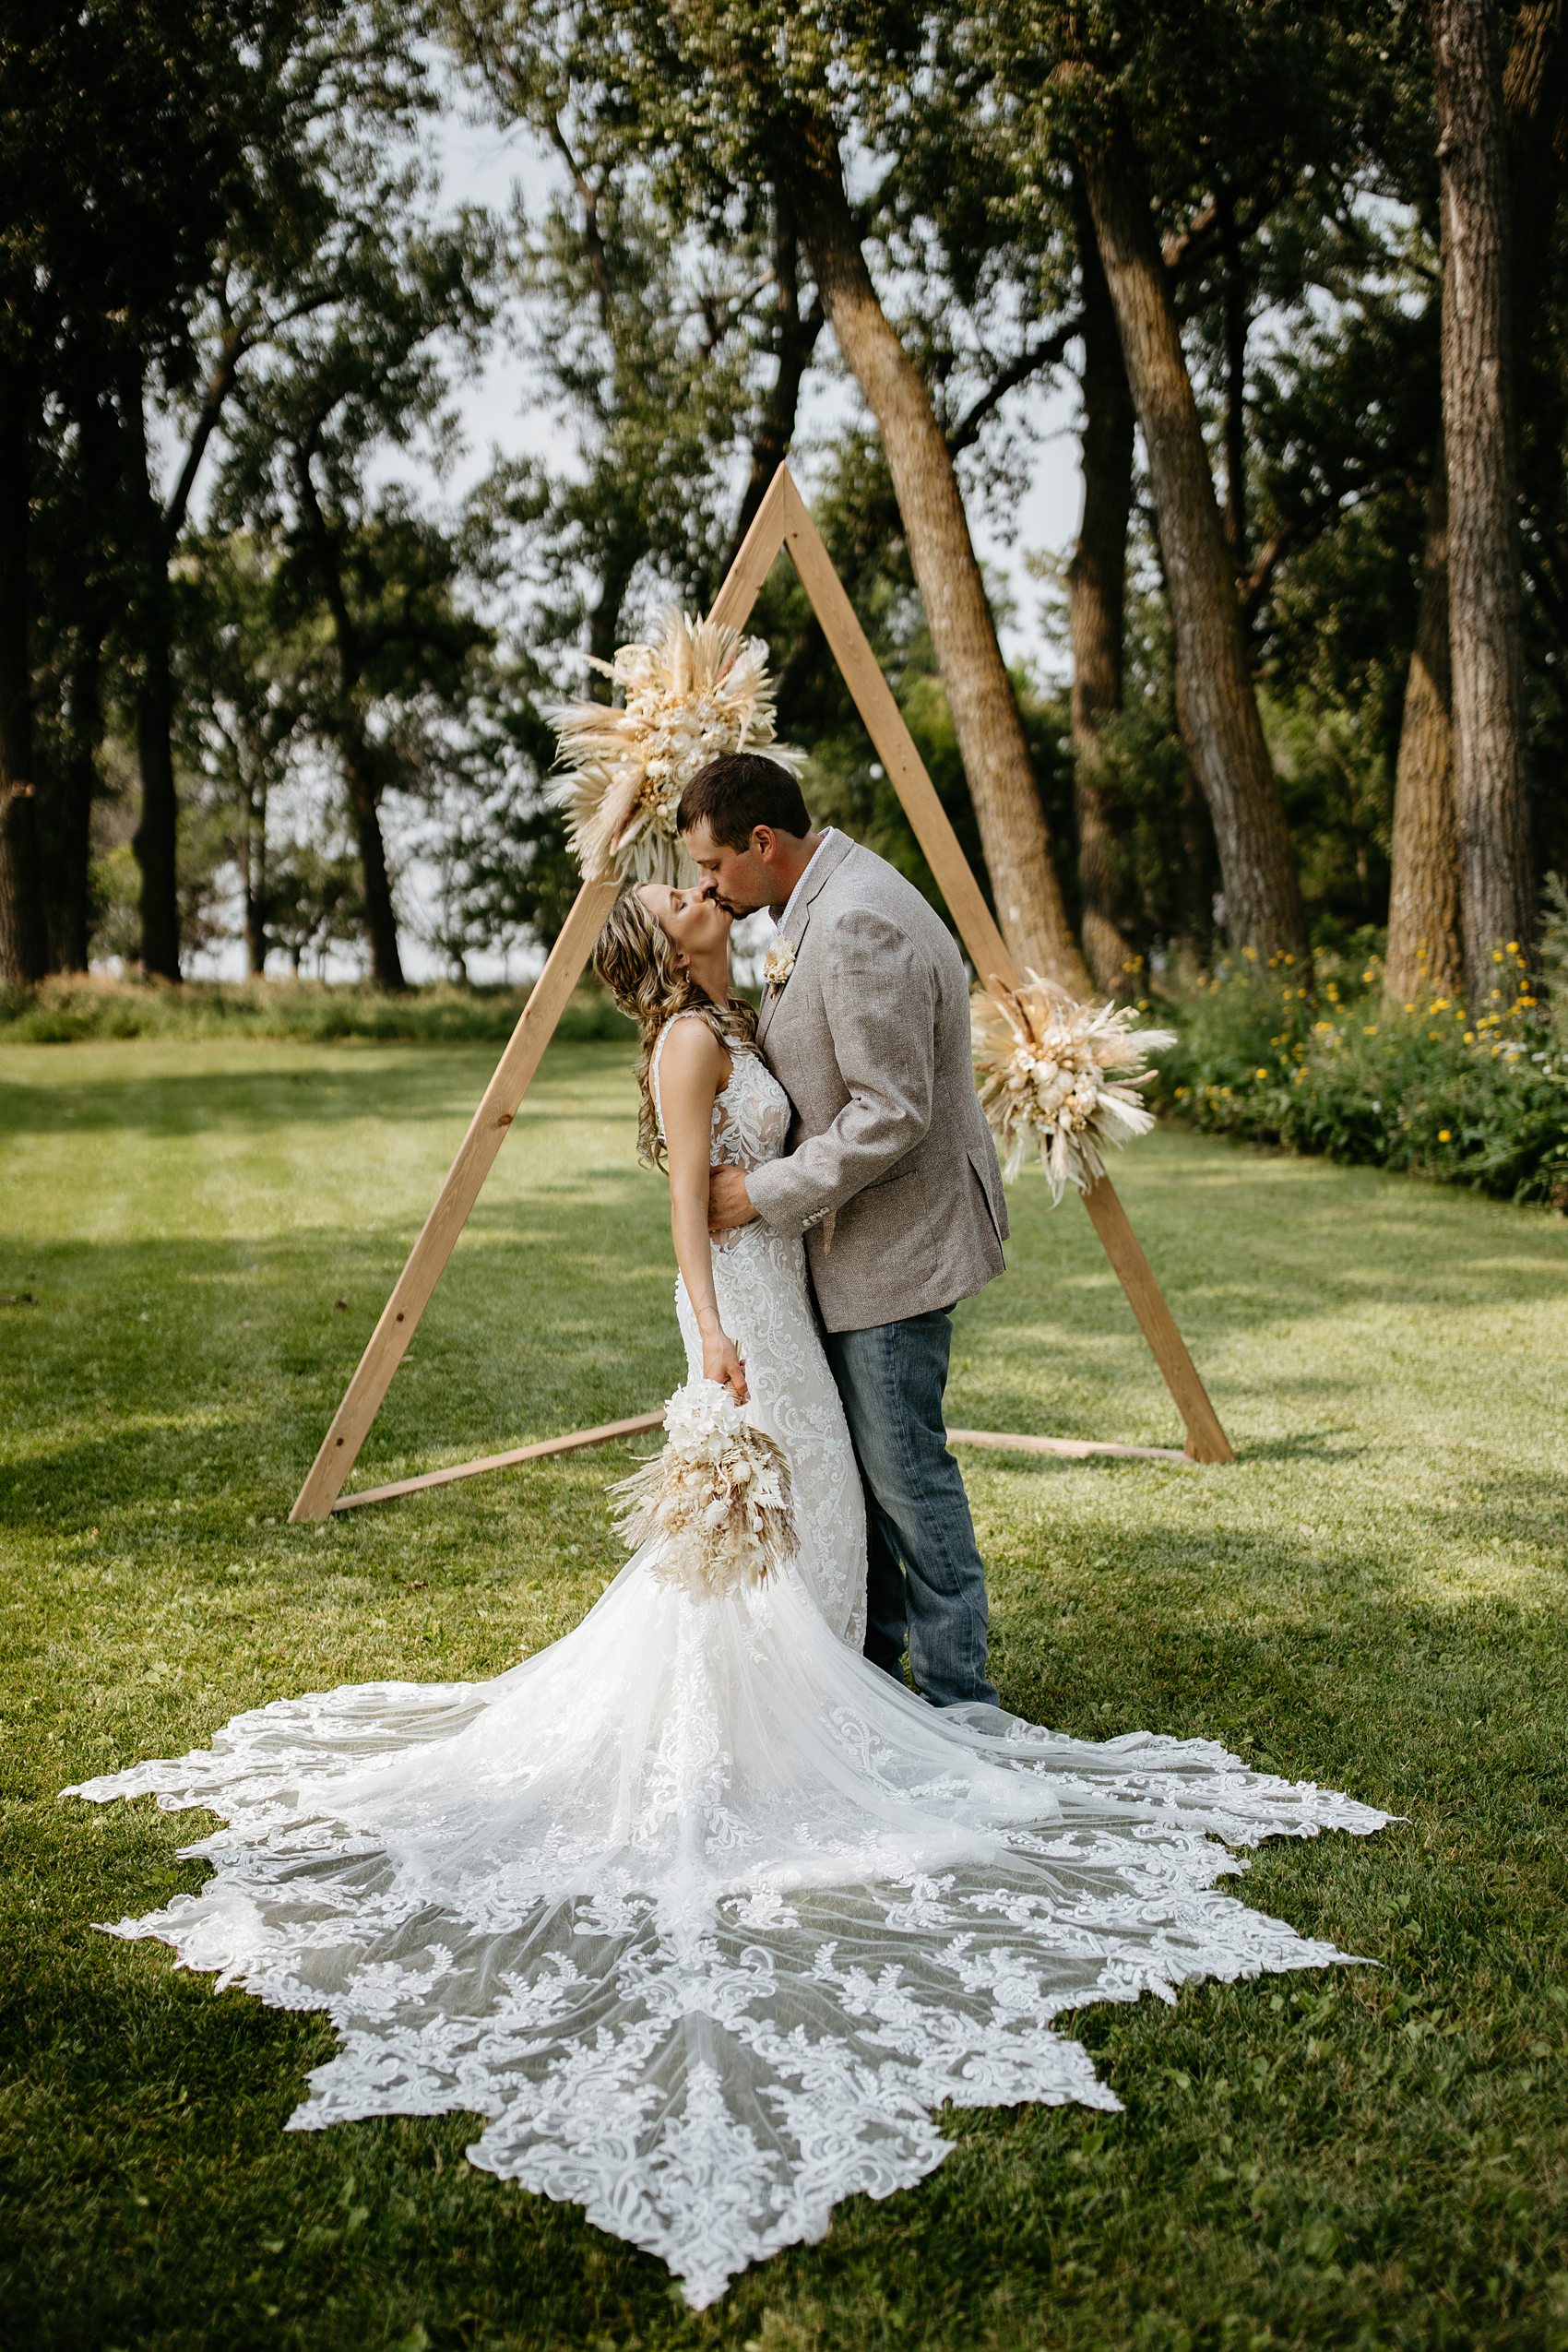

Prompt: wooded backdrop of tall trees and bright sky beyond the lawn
[0,0,1568,1004]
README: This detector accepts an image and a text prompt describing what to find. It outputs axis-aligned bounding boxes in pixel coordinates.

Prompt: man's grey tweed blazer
[747,833,1006,1331]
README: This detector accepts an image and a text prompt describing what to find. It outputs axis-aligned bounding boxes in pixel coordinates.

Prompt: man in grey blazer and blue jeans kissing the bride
[677,753,1006,1707]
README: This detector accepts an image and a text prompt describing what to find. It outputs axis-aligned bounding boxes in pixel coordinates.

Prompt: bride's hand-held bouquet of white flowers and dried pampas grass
[609,1381,800,1597]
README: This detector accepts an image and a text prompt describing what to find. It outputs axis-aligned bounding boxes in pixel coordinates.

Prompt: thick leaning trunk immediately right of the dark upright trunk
[1079,94,1310,967]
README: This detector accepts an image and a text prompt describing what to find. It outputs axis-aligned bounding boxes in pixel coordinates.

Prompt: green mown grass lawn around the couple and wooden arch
[0,1042,1568,2352]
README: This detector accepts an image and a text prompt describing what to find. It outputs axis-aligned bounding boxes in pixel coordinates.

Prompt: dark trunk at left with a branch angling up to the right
[123,369,179,980]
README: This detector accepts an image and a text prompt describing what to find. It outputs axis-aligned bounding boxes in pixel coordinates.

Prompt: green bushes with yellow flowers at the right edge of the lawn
[1157,920,1568,1209]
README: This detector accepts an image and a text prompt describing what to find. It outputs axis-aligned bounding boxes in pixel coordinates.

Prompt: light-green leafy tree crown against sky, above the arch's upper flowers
[445,0,770,663]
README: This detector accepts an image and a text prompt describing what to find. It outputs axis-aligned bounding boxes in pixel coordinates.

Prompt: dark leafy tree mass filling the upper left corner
[15,0,446,962]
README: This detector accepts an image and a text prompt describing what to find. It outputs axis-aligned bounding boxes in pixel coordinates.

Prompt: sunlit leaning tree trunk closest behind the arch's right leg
[790,127,1091,997]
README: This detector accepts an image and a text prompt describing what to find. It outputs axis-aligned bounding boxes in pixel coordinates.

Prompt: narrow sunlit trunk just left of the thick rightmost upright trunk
[1383,454,1465,1006]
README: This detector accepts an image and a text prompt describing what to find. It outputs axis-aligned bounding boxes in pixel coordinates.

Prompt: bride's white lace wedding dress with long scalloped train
[68,1020,1387,2308]
